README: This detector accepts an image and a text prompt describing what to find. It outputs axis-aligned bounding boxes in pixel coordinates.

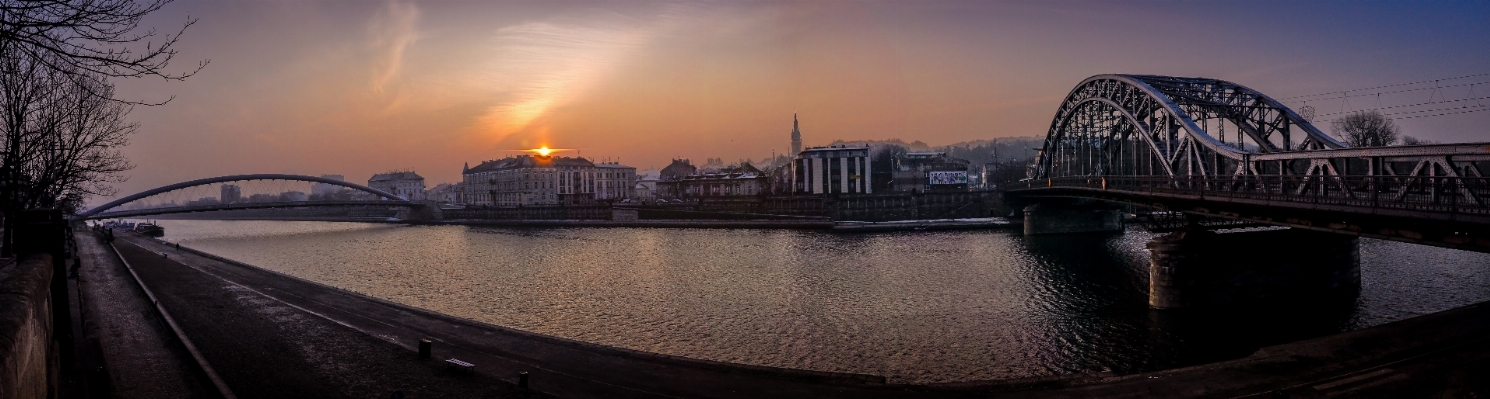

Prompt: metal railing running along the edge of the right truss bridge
[1010,176,1490,216]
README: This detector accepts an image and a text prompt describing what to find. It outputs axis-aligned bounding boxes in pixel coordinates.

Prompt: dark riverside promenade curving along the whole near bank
[79,232,1490,398]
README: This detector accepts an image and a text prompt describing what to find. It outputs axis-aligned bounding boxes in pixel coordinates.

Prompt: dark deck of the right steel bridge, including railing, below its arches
[1006,176,1490,252]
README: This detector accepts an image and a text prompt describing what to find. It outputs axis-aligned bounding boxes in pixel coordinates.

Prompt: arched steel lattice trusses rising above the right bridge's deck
[1031,74,1347,179]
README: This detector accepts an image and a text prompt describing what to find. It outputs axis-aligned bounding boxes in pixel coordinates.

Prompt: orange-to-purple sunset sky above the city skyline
[105,0,1490,204]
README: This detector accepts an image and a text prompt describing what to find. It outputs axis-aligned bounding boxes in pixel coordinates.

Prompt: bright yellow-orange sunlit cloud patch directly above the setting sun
[474,16,651,144]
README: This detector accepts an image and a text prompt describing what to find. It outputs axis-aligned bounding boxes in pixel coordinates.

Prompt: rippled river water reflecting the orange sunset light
[142,220,1490,383]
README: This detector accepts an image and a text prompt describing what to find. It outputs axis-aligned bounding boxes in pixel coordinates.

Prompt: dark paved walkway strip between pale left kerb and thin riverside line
[108,235,544,398]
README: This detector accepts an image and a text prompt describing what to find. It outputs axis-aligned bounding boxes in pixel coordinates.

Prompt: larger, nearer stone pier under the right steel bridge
[1147,229,1360,310]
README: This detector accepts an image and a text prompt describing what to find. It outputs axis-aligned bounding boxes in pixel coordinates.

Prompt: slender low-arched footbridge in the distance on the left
[75,174,419,220]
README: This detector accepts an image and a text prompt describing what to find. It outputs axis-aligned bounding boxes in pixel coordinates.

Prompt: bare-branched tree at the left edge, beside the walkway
[0,0,196,256]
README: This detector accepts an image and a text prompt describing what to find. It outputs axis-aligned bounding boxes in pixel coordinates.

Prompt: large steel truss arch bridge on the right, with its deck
[1006,74,1490,252]
